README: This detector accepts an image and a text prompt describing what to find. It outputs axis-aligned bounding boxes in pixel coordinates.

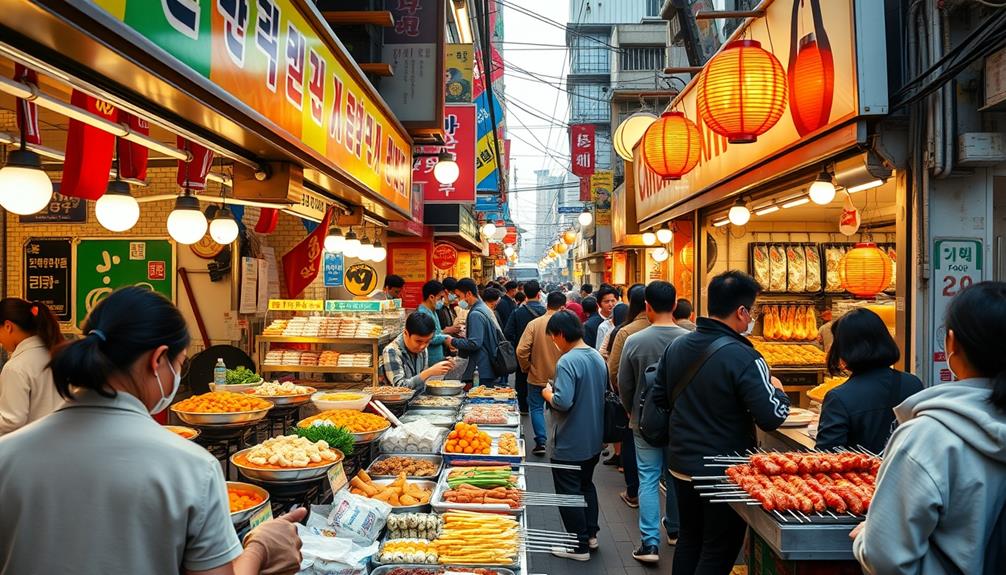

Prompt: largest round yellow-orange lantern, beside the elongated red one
[696,40,788,144]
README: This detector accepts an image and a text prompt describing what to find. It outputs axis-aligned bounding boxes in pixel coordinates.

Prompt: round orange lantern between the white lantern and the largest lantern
[642,112,702,180]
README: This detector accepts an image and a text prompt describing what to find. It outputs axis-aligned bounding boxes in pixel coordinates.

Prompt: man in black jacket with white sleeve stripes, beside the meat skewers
[653,270,790,575]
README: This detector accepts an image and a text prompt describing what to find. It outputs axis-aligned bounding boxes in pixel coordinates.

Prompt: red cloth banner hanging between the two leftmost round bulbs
[59,89,119,200]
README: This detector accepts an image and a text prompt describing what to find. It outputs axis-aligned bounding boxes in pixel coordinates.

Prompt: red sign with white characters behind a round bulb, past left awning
[412,104,475,203]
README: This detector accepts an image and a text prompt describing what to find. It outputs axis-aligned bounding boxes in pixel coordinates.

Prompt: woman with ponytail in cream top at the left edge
[0,298,63,436]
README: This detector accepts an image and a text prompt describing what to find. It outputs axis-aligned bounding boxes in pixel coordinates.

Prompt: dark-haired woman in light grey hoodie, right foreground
[852,281,1006,575]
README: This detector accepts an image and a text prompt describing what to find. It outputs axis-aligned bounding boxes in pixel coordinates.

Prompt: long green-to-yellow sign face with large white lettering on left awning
[96,0,408,212]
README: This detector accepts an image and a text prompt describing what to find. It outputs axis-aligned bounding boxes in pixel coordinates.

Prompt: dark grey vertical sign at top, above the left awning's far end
[380,0,446,130]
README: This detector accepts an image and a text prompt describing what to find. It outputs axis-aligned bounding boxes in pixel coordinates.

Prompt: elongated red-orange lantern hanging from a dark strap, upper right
[790,34,835,136]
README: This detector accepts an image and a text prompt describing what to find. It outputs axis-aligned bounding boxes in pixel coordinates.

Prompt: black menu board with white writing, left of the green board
[22,237,73,322]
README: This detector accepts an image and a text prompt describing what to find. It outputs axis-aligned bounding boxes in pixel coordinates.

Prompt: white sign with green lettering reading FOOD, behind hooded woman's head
[930,238,985,385]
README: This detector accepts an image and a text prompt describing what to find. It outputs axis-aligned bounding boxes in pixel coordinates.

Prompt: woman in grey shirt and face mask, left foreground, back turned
[0,288,306,575]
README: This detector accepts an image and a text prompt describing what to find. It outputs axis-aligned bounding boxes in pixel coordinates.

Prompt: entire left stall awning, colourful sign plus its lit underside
[0,0,412,219]
